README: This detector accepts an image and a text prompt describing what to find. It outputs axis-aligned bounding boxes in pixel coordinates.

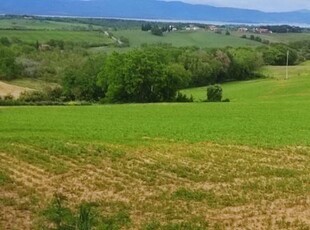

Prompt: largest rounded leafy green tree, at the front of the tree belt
[98,47,189,102]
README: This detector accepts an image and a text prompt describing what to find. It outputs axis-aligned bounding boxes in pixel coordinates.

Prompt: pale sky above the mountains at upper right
[167,0,310,12]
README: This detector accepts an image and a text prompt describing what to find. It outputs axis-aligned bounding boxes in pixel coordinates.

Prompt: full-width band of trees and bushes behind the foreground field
[0,31,310,103]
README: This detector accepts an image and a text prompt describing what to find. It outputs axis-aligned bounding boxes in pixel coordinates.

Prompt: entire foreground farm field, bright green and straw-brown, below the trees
[0,63,310,229]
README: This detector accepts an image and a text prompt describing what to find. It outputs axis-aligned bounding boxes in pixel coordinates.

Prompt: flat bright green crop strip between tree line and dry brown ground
[1,99,310,147]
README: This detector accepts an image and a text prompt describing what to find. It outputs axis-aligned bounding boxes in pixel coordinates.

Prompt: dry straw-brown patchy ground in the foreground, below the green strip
[0,143,310,229]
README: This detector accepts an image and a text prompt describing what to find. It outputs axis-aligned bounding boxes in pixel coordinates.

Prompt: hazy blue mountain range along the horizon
[0,0,310,25]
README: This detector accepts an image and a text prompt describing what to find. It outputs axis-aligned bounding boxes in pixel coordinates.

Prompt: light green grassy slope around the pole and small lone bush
[183,62,310,104]
